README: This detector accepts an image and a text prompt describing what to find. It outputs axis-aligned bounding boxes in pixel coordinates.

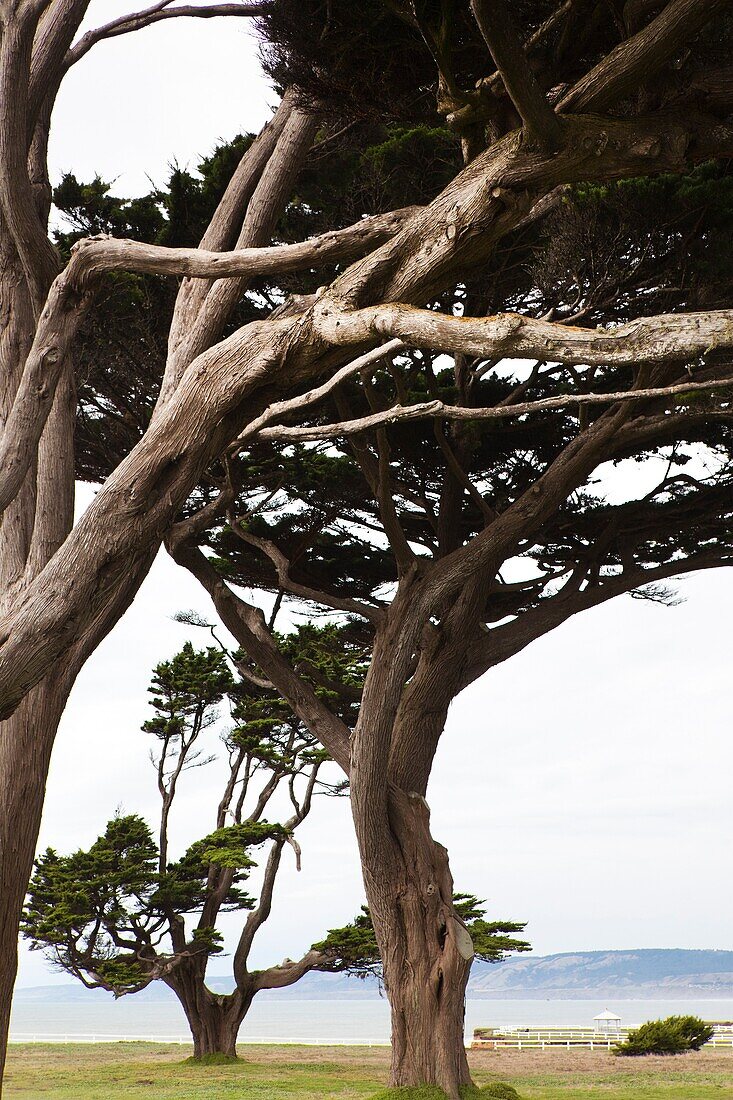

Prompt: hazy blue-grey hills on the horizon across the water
[15,949,733,1004]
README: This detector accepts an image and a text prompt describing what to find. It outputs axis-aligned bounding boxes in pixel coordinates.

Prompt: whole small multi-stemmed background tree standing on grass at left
[23,626,360,1057]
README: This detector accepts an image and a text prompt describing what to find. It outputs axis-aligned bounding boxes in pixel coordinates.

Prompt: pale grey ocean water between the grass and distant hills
[10,991,733,1045]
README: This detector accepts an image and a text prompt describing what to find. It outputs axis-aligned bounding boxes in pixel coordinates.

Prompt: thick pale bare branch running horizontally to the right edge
[315,301,733,366]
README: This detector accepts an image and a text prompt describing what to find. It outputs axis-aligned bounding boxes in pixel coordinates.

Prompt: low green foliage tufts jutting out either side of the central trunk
[313,894,532,978]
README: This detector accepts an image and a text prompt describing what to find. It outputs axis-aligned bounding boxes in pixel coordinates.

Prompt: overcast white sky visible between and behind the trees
[12,0,733,986]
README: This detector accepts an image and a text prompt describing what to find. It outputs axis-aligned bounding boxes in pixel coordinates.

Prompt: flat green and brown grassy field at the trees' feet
[3,1043,733,1100]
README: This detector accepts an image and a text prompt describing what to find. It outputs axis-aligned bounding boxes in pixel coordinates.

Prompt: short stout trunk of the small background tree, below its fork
[166,972,254,1058]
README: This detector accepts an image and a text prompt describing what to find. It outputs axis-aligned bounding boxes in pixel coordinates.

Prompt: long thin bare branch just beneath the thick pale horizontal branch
[260,378,733,435]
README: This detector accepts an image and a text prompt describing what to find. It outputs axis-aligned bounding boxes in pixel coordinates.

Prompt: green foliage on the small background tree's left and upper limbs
[23,626,363,996]
